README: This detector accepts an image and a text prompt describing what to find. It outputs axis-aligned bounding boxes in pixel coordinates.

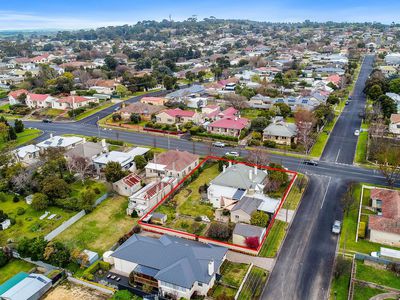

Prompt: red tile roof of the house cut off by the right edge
[368,189,400,234]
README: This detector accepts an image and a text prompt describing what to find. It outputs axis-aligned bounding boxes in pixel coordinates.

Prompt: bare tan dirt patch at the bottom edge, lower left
[43,282,110,300]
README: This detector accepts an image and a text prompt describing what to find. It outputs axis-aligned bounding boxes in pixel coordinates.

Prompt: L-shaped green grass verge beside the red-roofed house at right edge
[340,183,398,254]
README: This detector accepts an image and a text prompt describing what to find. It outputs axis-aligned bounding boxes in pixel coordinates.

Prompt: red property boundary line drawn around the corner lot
[138,155,298,254]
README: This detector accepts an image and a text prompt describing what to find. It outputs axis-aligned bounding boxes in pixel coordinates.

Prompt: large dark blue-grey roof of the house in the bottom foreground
[111,235,228,289]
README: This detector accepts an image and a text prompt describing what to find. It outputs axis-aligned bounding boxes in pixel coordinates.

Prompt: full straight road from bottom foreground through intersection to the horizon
[262,55,376,299]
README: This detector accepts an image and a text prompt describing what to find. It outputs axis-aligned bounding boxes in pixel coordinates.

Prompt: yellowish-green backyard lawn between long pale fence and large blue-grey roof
[56,197,137,255]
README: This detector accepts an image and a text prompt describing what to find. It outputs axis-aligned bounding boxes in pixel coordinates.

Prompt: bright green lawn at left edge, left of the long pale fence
[0,195,76,245]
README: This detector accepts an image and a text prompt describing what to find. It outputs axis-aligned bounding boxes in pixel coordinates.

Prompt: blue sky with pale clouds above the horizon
[0,0,400,30]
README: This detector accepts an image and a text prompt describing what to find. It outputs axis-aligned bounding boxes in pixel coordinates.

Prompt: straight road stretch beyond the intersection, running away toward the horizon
[321,55,374,164]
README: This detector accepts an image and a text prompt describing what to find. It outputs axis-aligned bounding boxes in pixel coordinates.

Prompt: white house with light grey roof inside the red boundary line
[207,163,268,208]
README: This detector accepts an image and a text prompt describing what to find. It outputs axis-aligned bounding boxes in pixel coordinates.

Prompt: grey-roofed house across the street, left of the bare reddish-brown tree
[263,120,297,146]
